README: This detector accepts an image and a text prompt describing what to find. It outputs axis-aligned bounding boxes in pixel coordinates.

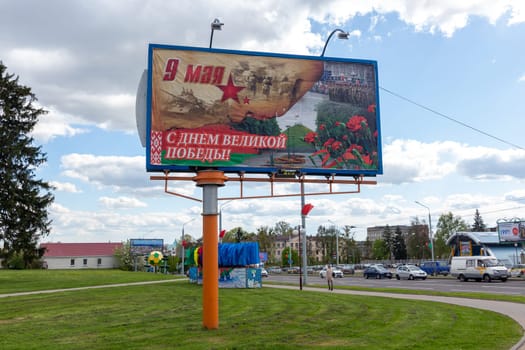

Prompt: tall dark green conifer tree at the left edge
[0,62,54,268]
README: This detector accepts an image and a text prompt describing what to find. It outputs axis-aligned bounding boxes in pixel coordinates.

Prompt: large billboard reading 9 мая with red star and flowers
[146,44,382,176]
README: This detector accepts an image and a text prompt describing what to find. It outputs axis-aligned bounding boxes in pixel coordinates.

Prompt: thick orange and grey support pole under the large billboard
[193,170,228,329]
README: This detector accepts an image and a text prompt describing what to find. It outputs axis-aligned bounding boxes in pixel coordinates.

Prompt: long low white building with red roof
[40,242,123,269]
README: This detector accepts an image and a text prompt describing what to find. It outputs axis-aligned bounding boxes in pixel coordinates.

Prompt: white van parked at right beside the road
[450,255,510,282]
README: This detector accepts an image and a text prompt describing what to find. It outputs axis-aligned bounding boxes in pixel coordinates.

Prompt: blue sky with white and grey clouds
[0,0,525,243]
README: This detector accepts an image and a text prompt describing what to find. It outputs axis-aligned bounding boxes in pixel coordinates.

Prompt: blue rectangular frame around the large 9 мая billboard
[146,44,383,177]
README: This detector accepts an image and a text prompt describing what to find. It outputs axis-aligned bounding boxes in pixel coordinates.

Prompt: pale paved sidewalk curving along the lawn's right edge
[264,284,525,350]
